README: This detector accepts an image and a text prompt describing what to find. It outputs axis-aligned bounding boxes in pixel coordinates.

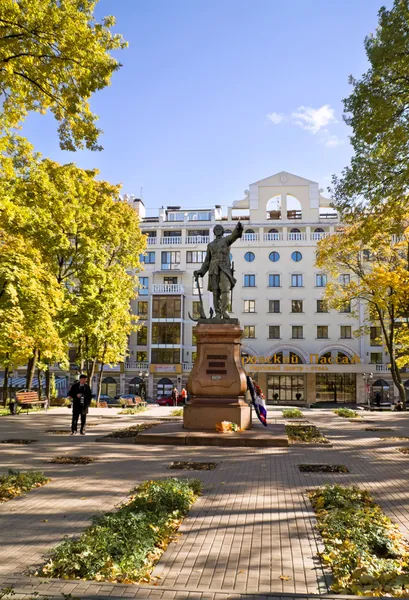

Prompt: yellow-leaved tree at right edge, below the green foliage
[317,206,409,405]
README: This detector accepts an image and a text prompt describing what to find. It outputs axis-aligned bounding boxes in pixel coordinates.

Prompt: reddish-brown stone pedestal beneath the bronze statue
[183,319,251,431]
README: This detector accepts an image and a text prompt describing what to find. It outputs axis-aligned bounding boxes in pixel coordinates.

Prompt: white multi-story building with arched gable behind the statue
[99,172,392,404]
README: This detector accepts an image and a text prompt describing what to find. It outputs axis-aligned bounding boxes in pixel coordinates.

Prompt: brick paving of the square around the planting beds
[0,407,409,600]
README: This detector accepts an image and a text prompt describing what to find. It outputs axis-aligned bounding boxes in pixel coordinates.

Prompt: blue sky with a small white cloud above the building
[23,0,390,214]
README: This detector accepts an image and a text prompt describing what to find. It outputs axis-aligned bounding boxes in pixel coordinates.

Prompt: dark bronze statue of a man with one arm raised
[194,221,243,319]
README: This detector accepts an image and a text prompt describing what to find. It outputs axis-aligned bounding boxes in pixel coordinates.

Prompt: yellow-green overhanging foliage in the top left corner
[0,0,127,150]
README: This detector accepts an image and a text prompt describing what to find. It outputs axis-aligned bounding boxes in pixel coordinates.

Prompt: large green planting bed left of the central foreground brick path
[37,478,202,583]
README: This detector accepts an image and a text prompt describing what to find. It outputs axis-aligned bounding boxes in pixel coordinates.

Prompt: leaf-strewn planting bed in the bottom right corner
[309,485,409,597]
